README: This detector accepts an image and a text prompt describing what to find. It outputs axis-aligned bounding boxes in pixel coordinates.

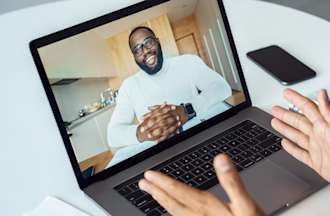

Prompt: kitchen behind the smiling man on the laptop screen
[39,0,244,174]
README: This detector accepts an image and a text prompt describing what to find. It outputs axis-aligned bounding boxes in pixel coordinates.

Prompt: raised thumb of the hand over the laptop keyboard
[214,154,256,213]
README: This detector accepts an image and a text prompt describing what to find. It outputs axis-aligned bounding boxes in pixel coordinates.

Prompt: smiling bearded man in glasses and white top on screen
[108,26,232,148]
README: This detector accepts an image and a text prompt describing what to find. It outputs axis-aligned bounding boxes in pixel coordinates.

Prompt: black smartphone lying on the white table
[247,45,316,85]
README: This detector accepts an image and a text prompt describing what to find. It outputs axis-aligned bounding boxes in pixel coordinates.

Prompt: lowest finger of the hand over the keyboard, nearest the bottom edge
[139,179,192,216]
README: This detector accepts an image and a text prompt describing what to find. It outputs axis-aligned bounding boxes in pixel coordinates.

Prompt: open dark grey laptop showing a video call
[30,0,326,216]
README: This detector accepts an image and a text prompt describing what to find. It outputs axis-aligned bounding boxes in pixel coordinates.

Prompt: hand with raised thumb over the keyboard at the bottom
[139,155,264,216]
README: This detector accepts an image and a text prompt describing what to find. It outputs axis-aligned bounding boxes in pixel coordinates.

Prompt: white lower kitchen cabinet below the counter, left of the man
[70,108,113,162]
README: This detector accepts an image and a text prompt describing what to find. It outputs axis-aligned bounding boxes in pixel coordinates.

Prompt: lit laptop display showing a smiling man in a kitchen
[37,0,246,176]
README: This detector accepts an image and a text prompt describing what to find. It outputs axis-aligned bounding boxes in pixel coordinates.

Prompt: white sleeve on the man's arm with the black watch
[190,56,232,119]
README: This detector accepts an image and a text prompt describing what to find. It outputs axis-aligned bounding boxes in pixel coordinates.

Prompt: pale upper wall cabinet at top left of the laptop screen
[38,31,115,79]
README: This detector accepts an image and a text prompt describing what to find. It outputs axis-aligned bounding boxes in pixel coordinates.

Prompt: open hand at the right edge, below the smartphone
[272,89,330,182]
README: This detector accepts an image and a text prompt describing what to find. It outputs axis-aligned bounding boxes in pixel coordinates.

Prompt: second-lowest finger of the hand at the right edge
[271,119,309,150]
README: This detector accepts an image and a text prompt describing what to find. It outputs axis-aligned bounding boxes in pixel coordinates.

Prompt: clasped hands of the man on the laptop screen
[137,104,188,142]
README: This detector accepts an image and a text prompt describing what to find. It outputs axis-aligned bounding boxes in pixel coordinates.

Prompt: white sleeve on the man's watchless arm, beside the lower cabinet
[107,82,140,148]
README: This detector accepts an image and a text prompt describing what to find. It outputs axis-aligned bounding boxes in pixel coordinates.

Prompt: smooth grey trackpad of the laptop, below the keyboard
[211,160,311,214]
